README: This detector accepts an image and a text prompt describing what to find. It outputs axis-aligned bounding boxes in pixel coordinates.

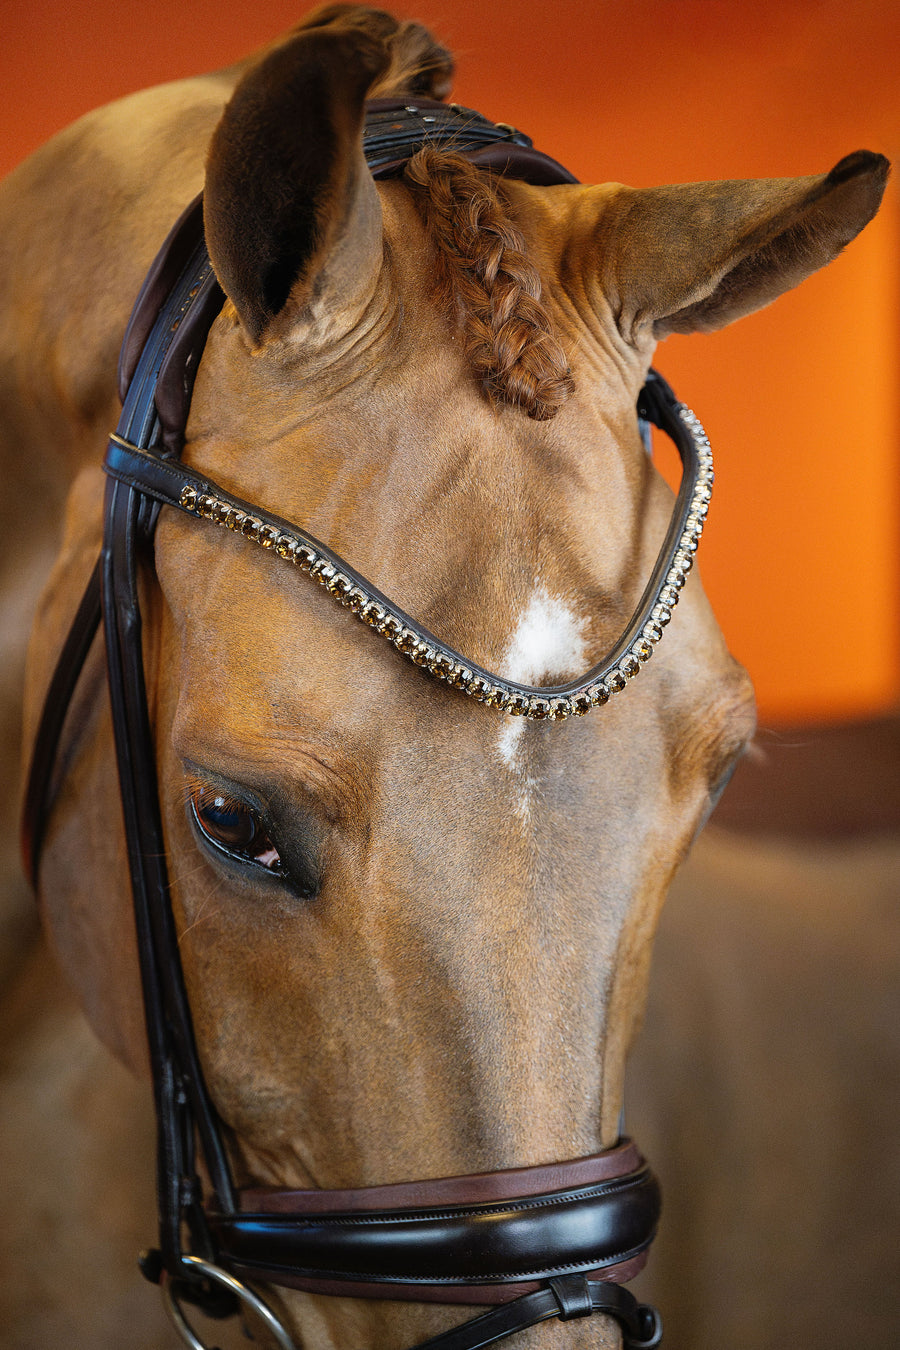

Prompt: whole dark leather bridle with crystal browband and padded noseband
[23,99,712,1350]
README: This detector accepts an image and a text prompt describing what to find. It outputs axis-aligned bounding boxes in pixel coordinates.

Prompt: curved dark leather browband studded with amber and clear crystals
[104,373,712,722]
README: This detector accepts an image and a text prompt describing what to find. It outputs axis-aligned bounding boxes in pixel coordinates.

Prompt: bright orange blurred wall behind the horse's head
[0,0,900,724]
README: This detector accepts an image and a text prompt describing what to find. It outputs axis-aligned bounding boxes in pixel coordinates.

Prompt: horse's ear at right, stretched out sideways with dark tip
[594,150,889,339]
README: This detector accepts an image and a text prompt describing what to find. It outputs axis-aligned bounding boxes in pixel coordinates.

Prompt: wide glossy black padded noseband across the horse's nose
[209,1146,660,1303]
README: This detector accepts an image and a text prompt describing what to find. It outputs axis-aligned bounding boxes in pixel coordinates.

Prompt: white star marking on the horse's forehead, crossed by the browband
[497,586,587,799]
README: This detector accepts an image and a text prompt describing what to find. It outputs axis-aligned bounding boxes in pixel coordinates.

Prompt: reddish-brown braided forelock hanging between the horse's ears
[405,149,575,421]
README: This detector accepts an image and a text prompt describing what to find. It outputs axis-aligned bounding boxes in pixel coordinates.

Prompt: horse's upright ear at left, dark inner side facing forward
[204,28,389,347]
